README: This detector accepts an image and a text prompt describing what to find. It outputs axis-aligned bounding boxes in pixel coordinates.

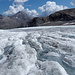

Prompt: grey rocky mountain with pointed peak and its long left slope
[0,11,31,29]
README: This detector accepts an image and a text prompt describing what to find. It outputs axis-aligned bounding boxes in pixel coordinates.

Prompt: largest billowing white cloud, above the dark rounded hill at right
[38,1,68,16]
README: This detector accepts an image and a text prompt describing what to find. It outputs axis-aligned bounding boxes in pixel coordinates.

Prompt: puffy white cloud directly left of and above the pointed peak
[3,5,24,15]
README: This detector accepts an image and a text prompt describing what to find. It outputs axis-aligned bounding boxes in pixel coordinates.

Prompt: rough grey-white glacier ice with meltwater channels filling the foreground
[0,26,75,75]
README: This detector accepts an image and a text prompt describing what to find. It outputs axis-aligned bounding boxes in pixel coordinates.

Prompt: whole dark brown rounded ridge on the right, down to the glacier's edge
[28,8,75,26]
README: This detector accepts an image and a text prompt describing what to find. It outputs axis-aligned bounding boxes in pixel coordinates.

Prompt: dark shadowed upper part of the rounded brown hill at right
[48,8,75,21]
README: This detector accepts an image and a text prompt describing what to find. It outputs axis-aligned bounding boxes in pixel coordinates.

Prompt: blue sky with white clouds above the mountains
[0,0,75,17]
